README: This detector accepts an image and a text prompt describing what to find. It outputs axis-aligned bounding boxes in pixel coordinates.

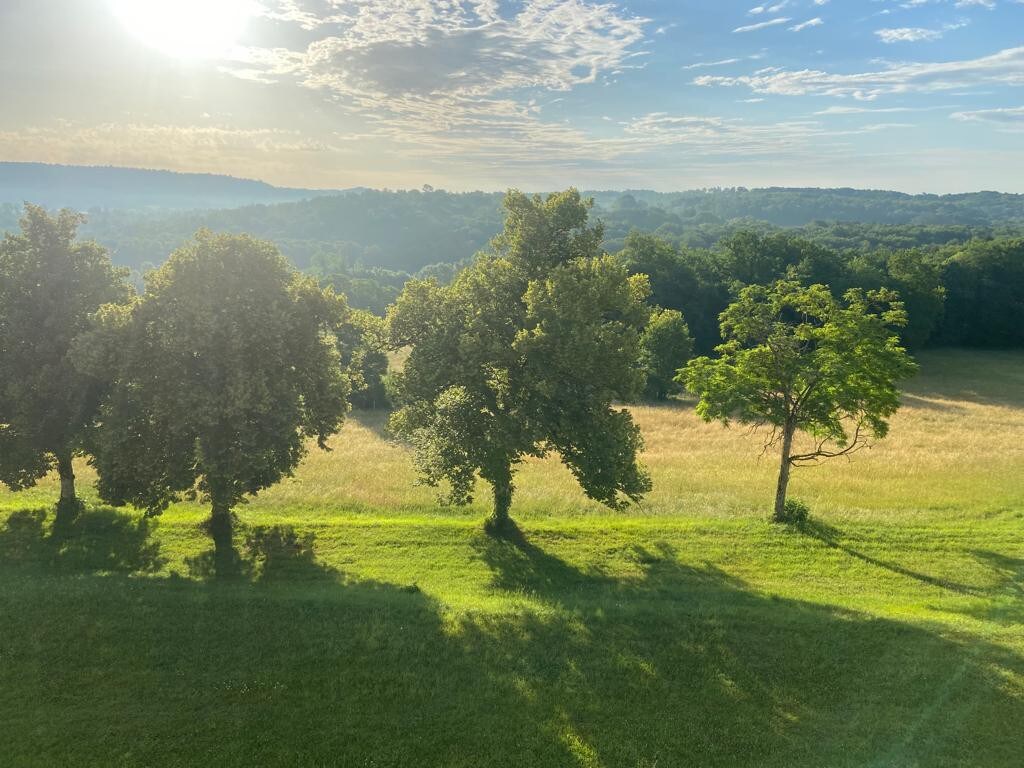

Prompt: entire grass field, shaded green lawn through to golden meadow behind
[0,352,1024,768]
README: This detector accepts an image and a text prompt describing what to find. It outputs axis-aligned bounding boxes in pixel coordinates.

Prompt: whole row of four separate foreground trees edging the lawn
[0,189,915,570]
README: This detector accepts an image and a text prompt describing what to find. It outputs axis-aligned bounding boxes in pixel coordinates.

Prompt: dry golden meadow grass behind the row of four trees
[0,351,1024,521]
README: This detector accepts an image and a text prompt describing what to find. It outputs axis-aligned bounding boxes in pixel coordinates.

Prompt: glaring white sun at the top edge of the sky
[109,0,255,58]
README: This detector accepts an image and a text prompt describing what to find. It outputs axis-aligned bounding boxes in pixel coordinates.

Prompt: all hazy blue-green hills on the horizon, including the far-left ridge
[0,168,1024,273]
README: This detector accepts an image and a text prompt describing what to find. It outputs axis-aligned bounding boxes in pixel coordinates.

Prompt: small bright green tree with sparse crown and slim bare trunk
[680,282,916,521]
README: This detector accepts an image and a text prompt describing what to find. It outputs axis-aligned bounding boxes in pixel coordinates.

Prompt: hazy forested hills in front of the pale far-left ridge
[6,189,1024,307]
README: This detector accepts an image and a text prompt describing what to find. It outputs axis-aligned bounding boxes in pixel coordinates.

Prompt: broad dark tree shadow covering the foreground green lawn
[0,515,1024,768]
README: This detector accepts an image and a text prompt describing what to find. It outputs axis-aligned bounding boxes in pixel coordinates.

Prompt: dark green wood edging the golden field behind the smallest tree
[618,229,1024,352]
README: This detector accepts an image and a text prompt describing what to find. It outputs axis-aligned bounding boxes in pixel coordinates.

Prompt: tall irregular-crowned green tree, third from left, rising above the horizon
[389,189,650,527]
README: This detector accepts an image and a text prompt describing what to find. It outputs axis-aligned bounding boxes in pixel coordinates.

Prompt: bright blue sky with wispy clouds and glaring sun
[0,0,1024,193]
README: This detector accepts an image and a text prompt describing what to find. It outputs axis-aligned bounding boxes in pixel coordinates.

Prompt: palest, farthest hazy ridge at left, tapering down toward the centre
[0,163,346,211]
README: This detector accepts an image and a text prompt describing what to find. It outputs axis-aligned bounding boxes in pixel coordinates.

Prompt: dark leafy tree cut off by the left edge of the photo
[0,205,131,516]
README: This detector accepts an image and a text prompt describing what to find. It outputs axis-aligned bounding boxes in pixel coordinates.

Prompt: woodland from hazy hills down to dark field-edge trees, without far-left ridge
[0,187,1024,352]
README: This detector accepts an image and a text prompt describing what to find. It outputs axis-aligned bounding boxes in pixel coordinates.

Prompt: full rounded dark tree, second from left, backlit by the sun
[79,231,349,570]
